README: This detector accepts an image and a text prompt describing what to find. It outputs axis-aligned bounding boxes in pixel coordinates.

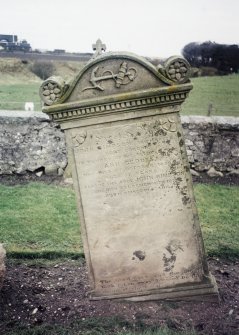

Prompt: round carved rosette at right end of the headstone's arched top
[165,57,191,84]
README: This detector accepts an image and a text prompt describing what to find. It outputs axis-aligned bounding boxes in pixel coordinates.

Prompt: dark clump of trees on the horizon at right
[182,41,239,74]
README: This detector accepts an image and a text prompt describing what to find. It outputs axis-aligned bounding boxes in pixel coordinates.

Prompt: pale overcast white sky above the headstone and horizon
[0,0,239,57]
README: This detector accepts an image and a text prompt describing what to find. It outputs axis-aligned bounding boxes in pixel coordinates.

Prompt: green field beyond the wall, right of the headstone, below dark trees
[182,74,239,116]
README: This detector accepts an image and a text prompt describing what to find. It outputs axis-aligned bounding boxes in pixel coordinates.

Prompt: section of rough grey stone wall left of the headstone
[0,111,67,174]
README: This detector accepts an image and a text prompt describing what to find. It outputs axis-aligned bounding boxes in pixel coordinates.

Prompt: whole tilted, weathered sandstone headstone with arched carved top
[40,43,217,301]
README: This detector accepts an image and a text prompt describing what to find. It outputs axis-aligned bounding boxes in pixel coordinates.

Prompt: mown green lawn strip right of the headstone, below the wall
[195,184,239,257]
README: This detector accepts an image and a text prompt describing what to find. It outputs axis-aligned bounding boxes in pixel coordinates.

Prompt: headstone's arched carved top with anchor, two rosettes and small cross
[40,50,192,110]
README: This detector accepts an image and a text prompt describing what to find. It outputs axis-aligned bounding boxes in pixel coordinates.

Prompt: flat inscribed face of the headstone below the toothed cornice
[72,115,202,294]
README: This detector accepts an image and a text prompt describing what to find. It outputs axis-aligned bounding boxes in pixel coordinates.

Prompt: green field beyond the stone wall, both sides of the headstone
[0,70,239,116]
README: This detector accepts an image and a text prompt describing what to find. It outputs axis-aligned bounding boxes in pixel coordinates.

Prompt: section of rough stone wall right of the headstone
[181,116,239,175]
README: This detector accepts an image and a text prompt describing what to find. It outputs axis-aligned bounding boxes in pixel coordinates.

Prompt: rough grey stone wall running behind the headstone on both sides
[0,111,239,176]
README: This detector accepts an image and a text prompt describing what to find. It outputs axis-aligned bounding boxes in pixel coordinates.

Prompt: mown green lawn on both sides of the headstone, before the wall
[0,183,239,259]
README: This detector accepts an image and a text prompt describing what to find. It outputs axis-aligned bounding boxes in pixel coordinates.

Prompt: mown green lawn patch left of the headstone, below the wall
[0,183,82,258]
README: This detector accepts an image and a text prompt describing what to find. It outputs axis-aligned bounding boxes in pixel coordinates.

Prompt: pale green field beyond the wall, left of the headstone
[0,83,41,111]
